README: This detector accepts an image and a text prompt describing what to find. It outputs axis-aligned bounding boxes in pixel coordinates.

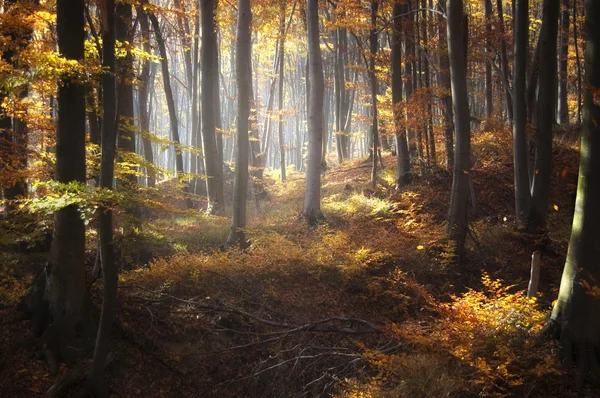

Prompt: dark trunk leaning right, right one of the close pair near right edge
[527,0,560,232]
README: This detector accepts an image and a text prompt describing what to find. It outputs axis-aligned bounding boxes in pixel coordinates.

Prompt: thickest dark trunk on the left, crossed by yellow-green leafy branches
[44,0,92,361]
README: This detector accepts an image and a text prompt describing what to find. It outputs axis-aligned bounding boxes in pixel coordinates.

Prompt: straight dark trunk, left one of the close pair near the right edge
[513,0,531,226]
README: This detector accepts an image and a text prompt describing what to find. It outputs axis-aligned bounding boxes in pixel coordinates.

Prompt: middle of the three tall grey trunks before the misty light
[227,0,252,247]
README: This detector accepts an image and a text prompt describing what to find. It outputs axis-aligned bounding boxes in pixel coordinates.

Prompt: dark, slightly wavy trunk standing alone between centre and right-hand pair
[447,0,471,256]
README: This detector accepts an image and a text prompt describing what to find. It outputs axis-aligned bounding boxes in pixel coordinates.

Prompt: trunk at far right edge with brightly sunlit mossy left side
[550,0,600,382]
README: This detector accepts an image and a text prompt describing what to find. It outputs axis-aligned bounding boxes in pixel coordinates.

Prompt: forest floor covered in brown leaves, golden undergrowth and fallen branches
[0,126,600,397]
